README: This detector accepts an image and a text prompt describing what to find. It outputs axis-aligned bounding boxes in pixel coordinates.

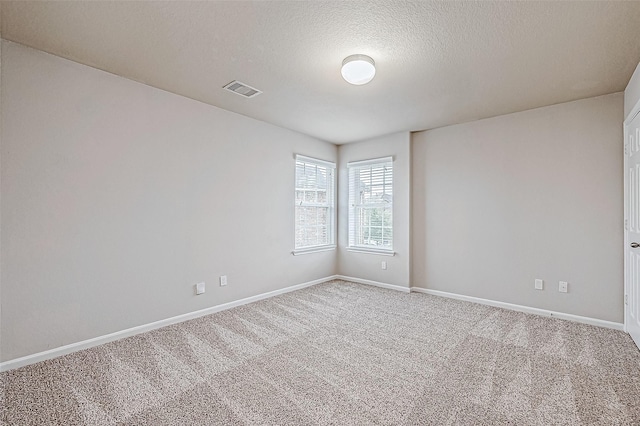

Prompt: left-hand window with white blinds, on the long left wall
[294,155,336,254]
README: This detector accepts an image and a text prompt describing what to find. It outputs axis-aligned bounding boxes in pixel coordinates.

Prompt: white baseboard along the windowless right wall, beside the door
[411,287,624,331]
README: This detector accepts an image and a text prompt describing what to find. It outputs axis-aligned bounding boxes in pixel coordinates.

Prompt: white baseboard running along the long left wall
[0,275,338,372]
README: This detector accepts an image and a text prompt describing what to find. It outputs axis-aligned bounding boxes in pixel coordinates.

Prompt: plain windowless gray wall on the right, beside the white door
[411,93,623,322]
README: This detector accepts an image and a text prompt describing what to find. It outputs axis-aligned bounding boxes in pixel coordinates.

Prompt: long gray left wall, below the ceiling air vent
[0,41,337,361]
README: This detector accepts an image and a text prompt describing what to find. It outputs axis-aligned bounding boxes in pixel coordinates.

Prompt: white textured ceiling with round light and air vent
[1,1,640,143]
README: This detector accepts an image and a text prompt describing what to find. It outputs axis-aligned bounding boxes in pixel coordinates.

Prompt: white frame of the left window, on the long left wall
[292,155,336,255]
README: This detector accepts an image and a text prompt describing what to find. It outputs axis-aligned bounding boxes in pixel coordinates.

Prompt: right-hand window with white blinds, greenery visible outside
[347,157,393,254]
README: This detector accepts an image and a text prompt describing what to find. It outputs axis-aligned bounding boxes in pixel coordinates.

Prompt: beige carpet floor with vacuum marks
[0,281,640,425]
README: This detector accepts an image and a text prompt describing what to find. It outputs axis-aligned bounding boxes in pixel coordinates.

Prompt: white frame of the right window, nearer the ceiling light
[347,157,395,256]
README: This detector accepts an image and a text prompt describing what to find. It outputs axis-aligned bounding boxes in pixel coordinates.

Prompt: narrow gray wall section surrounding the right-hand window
[338,132,411,288]
